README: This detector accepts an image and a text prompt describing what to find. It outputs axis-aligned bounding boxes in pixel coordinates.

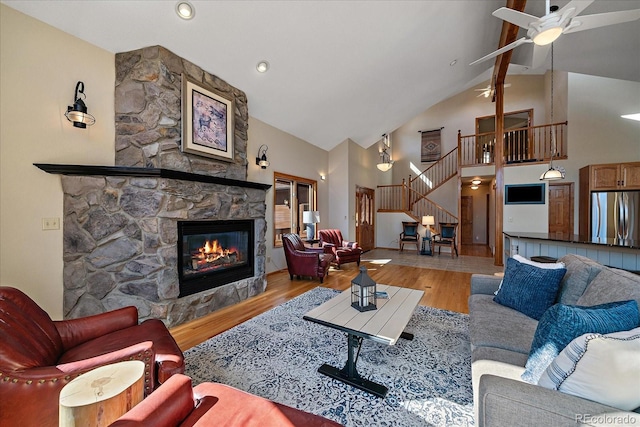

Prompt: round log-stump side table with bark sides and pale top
[59,360,144,427]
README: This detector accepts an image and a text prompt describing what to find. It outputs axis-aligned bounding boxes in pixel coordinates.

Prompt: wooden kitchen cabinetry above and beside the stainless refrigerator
[578,162,640,236]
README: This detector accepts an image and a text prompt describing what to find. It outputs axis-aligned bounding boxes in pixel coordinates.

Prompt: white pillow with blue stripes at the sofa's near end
[538,328,640,411]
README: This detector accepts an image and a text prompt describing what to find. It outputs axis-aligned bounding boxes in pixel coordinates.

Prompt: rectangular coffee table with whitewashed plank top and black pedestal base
[303,284,424,397]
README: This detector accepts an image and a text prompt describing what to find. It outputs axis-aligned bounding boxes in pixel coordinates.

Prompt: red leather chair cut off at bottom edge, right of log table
[110,375,341,427]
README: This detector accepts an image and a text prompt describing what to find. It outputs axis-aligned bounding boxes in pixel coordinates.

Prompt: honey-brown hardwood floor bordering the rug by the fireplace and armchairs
[171,261,471,351]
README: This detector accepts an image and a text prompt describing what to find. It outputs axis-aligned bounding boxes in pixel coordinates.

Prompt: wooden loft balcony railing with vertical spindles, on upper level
[458,122,567,166]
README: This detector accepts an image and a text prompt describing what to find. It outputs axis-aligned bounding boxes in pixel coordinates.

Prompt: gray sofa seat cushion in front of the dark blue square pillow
[469,294,538,356]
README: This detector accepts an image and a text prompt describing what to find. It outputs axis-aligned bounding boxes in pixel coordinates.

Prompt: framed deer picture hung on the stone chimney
[181,74,234,162]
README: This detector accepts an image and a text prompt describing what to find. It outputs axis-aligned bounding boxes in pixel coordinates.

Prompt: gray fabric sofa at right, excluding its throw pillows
[469,254,640,427]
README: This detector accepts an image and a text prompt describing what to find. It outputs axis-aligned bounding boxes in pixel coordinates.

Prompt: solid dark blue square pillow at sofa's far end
[493,258,567,320]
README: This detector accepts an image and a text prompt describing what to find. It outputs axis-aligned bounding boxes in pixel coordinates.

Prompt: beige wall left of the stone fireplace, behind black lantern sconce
[0,5,115,319]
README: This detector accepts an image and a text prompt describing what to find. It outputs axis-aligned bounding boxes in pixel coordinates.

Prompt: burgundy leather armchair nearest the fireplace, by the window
[282,234,333,283]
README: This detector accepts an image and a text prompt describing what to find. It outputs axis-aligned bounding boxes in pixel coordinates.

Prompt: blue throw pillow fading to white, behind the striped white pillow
[521,300,640,384]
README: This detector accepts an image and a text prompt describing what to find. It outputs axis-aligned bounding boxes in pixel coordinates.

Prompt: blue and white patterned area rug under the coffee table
[185,287,474,427]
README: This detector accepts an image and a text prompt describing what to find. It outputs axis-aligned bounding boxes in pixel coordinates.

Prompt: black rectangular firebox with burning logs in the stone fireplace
[178,220,254,297]
